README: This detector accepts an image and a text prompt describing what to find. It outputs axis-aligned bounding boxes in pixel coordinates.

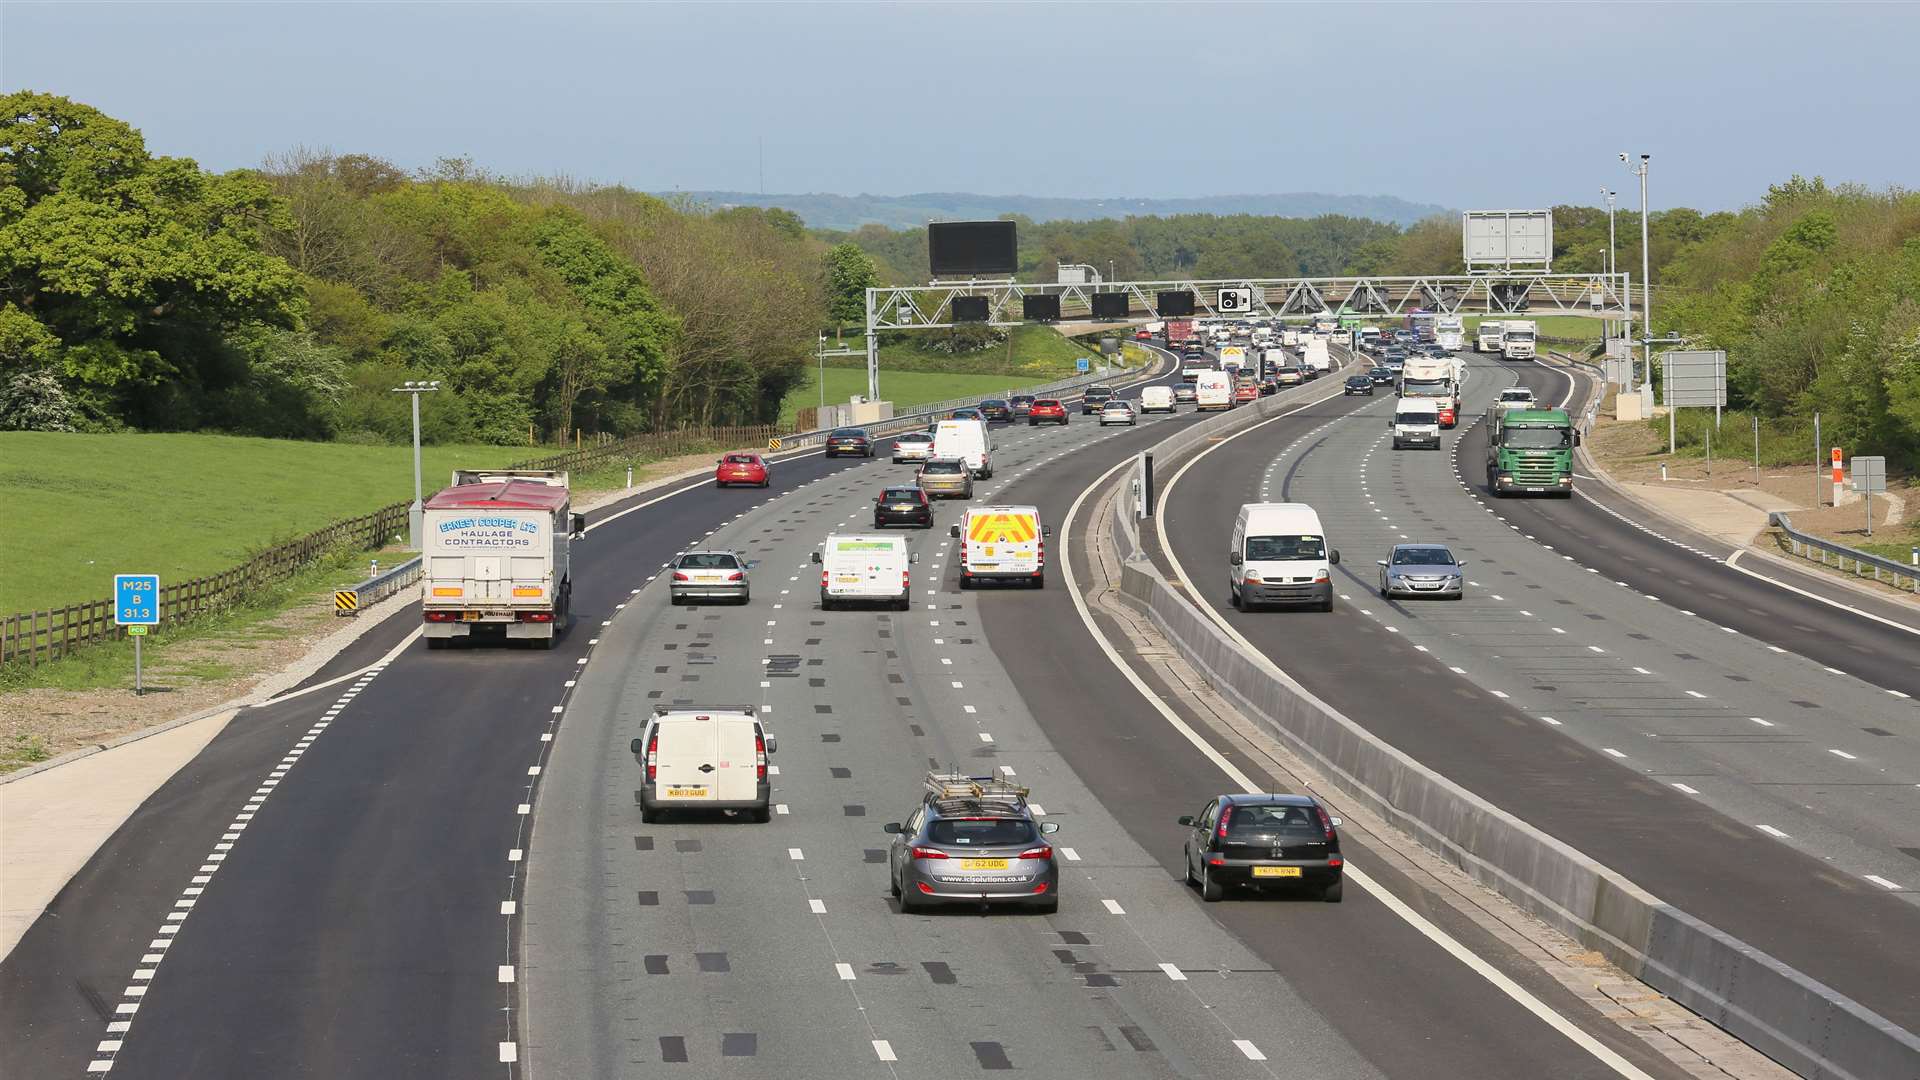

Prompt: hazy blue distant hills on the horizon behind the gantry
[660,192,1453,231]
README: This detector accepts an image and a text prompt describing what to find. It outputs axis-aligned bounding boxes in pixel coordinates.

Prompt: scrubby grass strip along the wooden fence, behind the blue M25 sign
[0,550,369,691]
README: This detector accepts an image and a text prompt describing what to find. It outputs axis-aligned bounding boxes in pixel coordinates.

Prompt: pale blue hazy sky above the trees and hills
[0,0,1920,209]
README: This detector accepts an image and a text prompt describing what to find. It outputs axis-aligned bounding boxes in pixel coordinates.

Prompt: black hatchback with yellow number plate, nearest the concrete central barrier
[1181,794,1346,903]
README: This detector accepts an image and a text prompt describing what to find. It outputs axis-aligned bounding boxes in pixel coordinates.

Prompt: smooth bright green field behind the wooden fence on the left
[0,432,538,615]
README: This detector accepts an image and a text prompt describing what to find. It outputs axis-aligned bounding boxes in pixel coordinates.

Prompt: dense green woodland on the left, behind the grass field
[0,92,833,442]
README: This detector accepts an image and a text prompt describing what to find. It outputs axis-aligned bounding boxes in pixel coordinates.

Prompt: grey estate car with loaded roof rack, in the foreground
[885,774,1060,915]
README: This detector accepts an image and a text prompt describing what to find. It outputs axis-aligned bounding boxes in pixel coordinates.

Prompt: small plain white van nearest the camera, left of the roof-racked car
[630,705,776,822]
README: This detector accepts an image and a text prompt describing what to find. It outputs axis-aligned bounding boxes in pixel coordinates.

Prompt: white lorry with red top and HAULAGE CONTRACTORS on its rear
[420,469,586,650]
